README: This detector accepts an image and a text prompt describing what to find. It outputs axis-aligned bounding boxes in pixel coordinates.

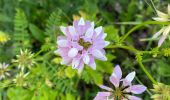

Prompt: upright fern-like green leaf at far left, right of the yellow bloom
[13,9,31,53]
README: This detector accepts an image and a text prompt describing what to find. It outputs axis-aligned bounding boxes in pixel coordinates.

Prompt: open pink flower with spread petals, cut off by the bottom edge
[94,65,146,100]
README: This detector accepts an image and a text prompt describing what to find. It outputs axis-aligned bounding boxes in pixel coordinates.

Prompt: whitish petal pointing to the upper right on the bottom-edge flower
[123,71,136,87]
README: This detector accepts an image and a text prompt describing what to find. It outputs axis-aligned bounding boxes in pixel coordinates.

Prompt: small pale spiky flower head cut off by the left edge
[0,63,10,80]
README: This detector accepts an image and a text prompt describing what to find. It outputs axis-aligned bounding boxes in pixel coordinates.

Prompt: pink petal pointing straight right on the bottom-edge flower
[125,85,146,94]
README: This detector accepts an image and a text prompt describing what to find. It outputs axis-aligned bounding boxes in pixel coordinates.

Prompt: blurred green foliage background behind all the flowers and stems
[0,0,170,100]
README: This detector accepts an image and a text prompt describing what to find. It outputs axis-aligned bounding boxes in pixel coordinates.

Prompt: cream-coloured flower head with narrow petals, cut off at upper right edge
[153,5,170,47]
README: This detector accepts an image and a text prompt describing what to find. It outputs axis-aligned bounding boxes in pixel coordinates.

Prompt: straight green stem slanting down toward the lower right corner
[138,61,157,84]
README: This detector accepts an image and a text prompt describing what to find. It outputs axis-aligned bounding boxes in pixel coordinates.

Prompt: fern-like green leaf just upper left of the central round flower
[45,8,62,41]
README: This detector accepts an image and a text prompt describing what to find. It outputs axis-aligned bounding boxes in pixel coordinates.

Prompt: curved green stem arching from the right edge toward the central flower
[120,21,170,43]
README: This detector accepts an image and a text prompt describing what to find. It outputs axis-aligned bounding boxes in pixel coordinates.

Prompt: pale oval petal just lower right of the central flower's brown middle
[92,49,107,61]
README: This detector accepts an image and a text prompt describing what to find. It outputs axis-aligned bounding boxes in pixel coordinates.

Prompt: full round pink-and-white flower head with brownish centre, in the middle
[56,18,109,72]
